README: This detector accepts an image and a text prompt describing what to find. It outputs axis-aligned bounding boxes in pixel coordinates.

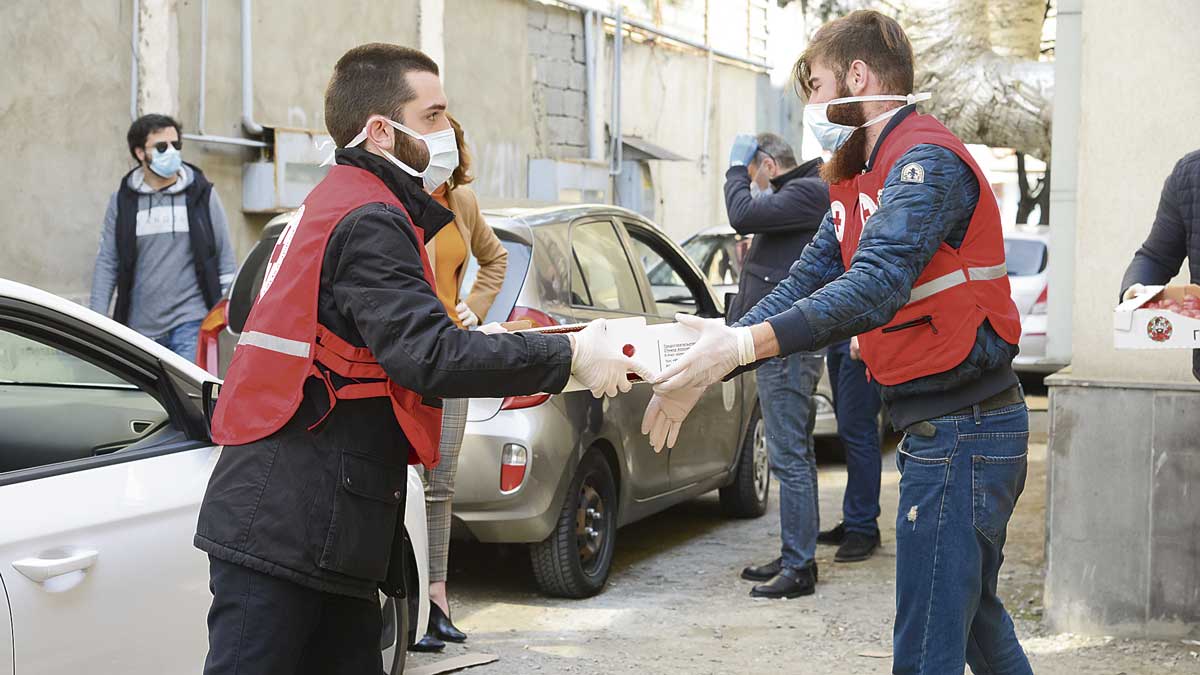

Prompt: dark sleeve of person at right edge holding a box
[1117,157,1200,299]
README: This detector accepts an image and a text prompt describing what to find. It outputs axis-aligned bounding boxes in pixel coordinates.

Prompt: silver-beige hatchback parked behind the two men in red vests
[216,205,770,597]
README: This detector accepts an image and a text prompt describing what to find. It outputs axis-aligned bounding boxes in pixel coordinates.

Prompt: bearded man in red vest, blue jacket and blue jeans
[643,11,1032,674]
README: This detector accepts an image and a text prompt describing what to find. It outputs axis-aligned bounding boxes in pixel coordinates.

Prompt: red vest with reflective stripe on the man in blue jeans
[829,113,1021,386]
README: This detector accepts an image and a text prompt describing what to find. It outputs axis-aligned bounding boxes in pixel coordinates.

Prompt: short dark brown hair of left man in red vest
[325,42,438,148]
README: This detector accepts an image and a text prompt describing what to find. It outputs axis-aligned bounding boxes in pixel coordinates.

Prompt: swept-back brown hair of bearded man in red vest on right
[793,10,913,96]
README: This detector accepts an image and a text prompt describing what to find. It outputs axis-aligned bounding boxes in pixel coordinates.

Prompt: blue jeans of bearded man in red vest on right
[893,404,1033,675]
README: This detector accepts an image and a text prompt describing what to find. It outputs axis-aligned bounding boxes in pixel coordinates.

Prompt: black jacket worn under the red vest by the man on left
[194,149,571,598]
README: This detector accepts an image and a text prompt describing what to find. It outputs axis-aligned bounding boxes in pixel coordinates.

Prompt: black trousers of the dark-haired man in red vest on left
[204,556,383,675]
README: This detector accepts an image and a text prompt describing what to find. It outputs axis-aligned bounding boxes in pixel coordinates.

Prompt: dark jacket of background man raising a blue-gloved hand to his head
[725,157,829,322]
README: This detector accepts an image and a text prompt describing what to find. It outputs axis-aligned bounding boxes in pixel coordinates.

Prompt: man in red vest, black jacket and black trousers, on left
[194,43,653,675]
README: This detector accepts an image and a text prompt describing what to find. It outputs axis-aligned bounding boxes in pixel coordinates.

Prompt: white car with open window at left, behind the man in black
[0,279,428,675]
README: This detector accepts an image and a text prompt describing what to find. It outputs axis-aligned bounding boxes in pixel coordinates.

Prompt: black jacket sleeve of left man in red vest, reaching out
[332,204,571,399]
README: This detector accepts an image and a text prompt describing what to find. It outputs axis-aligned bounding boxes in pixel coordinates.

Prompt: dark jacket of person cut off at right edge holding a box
[1120,150,1200,380]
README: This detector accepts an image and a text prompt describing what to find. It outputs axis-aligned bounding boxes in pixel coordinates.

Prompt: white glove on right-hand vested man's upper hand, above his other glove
[654,313,755,394]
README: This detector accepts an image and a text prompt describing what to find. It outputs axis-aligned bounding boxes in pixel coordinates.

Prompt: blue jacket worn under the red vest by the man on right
[738,115,1018,429]
